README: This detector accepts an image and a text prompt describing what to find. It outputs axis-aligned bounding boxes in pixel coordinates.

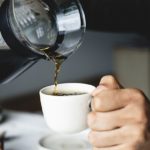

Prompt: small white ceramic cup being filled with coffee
[40,83,95,133]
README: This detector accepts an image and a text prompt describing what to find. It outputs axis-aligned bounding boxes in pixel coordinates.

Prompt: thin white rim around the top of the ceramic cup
[39,82,96,97]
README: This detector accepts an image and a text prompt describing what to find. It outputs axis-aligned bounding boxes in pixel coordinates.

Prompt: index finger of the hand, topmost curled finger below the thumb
[92,89,132,112]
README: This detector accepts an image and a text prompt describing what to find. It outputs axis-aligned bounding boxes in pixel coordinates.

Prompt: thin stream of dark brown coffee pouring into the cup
[43,48,66,95]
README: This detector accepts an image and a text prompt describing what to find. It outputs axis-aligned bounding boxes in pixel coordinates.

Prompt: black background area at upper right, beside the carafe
[81,0,150,36]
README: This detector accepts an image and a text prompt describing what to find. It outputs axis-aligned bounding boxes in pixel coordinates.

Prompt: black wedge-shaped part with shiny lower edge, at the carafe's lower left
[0,50,37,84]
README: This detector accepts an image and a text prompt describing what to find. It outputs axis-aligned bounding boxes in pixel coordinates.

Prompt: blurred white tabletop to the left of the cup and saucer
[0,110,51,150]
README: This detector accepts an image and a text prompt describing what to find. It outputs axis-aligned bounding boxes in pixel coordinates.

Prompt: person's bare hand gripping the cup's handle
[88,75,150,150]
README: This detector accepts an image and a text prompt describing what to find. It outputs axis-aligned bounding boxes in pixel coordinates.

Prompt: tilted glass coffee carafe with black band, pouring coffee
[0,0,86,83]
